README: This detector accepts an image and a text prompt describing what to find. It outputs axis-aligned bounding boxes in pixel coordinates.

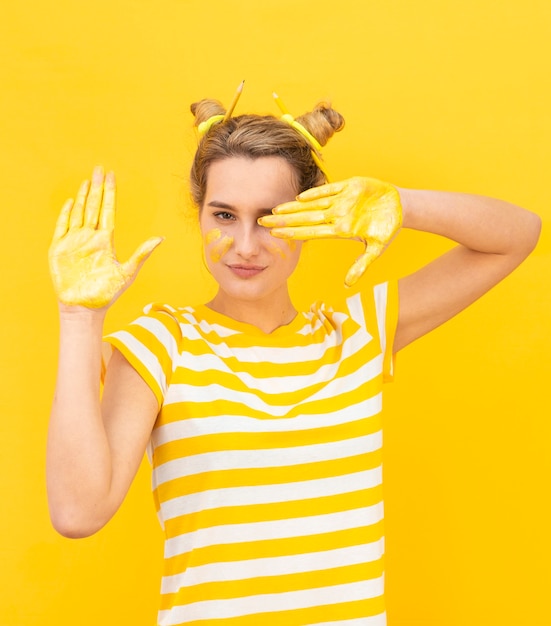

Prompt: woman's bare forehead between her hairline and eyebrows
[205,156,298,207]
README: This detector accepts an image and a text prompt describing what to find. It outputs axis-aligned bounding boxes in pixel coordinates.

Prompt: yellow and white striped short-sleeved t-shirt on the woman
[108,283,397,626]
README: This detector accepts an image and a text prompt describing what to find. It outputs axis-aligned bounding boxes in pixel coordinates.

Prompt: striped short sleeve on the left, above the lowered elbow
[104,304,181,406]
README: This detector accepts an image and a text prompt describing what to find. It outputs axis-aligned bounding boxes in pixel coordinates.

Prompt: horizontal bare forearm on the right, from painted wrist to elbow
[399,189,541,262]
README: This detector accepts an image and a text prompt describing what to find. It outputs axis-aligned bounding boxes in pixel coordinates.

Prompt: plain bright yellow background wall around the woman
[0,0,551,626]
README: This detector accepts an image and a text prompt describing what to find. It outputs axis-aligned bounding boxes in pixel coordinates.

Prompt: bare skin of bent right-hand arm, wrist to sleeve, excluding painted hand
[394,189,541,351]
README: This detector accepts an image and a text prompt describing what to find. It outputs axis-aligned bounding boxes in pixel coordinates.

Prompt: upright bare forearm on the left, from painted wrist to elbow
[47,307,115,534]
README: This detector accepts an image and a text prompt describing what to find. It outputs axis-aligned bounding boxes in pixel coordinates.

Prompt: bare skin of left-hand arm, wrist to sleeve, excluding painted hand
[46,307,159,537]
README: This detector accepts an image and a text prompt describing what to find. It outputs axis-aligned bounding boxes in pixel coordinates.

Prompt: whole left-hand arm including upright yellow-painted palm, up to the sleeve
[46,168,160,537]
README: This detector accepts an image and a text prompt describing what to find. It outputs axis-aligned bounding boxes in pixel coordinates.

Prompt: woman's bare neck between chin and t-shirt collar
[206,290,297,334]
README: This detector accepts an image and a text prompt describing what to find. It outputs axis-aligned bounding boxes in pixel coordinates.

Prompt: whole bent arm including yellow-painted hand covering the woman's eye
[259,177,541,351]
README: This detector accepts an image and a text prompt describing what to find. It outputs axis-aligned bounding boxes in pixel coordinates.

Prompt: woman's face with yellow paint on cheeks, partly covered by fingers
[200,157,301,305]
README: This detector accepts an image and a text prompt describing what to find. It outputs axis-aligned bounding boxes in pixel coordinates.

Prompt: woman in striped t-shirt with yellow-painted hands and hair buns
[48,94,540,626]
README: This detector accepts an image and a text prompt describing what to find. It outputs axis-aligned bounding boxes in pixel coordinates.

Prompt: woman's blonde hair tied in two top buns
[190,100,344,207]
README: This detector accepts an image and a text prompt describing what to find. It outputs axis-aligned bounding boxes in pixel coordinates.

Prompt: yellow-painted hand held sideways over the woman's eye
[259,177,402,286]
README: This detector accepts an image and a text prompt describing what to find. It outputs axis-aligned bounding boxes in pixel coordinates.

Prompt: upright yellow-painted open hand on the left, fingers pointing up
[48,167,162,309]
